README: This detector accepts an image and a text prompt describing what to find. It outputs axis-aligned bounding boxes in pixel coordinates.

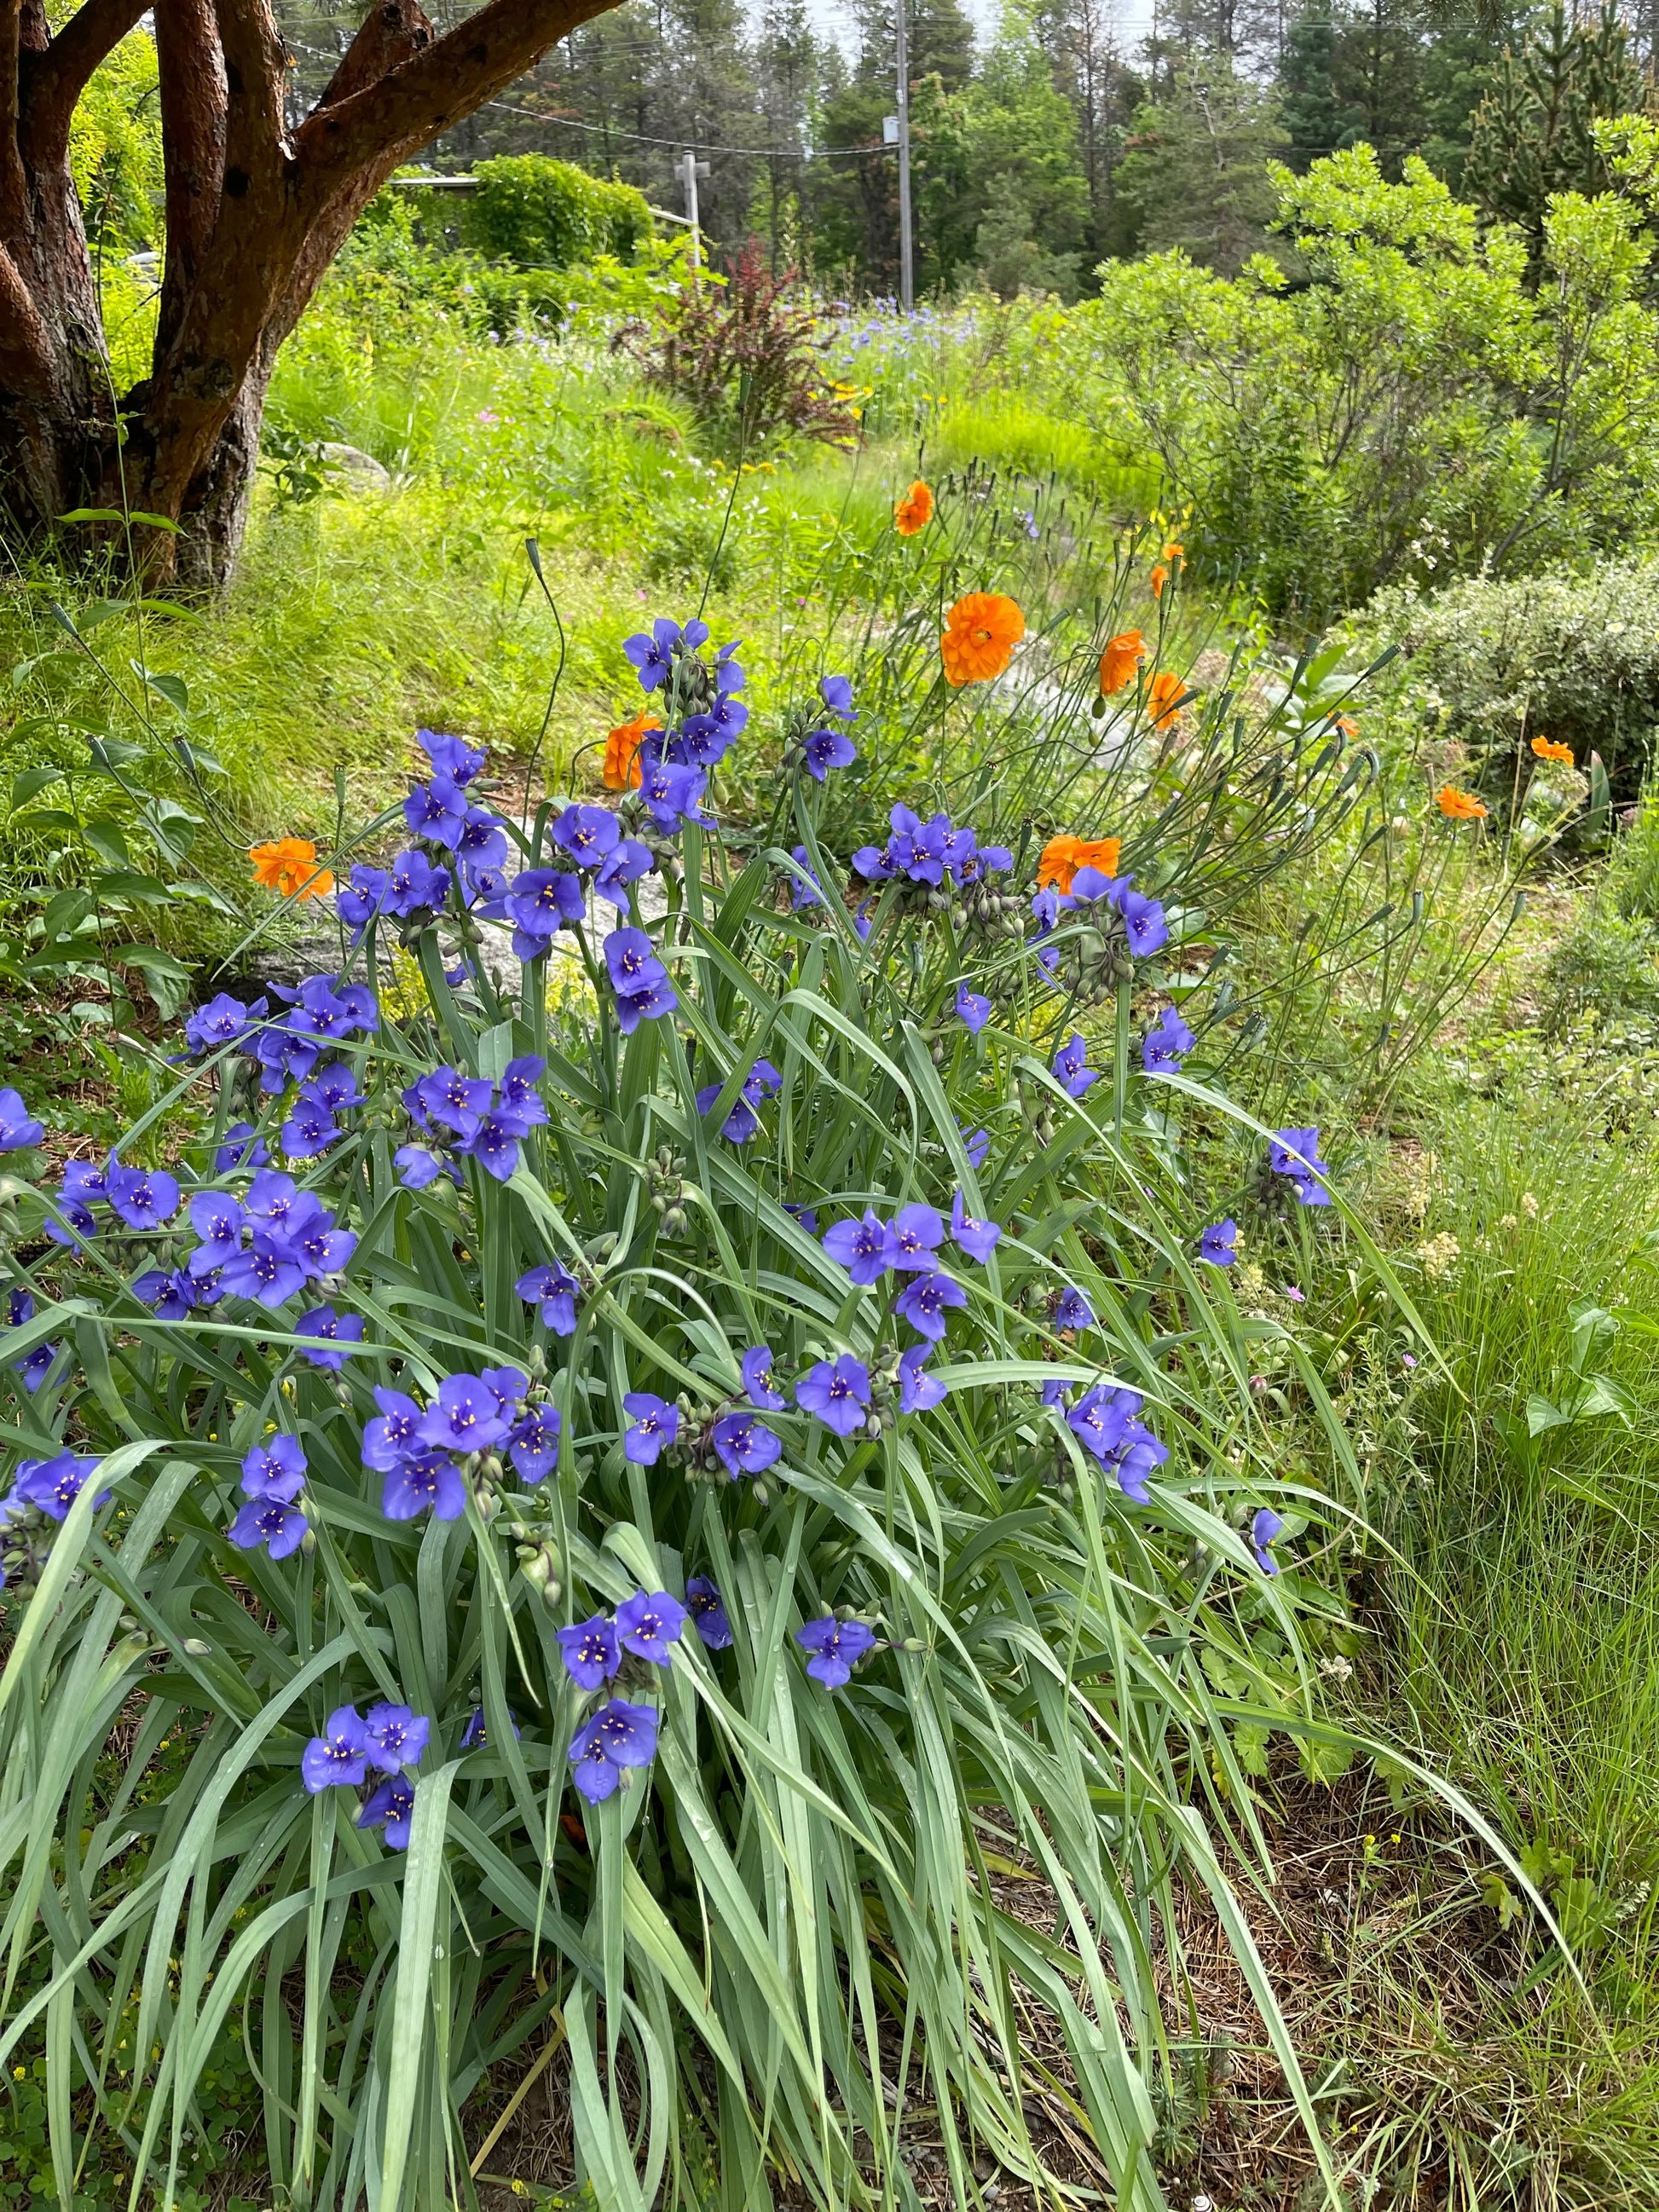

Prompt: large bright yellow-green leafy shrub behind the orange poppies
[1060,146,1659,621]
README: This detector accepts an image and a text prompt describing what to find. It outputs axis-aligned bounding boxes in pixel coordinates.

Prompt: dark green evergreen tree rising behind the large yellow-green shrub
[1465,0,1645,283]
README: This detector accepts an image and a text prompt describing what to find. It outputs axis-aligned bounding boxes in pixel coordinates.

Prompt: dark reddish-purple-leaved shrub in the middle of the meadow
[617,239,858,449]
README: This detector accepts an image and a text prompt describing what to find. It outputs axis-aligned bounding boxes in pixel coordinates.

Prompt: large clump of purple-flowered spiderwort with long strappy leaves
[0,584,1389,2212]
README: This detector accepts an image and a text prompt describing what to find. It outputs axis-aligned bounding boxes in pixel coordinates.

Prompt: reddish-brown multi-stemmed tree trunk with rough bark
[0,0,615,591]
